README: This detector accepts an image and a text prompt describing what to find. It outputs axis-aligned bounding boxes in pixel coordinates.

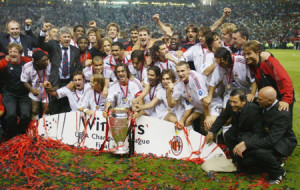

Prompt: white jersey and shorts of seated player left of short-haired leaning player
[156,88,193,121]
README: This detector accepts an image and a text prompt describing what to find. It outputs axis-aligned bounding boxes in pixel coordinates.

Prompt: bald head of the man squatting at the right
[257,86,277,107]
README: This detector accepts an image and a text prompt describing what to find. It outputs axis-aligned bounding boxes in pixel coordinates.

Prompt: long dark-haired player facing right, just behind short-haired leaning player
[151,40,178,73]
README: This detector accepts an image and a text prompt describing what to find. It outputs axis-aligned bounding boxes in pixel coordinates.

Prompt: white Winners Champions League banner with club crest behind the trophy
[38,112,225,160]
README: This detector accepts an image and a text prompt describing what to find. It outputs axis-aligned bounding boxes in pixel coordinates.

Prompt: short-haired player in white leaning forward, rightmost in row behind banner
[167,61,209,133]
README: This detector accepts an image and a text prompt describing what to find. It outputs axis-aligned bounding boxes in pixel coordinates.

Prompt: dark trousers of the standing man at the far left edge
[3,92,31,138]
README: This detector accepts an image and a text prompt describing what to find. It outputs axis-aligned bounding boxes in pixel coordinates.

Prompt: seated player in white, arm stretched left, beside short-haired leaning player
[135,69,193,129]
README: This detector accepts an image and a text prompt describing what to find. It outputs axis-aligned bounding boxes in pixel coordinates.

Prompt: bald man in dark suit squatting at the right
[233,86,297,184]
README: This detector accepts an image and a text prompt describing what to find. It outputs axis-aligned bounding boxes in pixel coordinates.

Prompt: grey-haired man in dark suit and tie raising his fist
[38,23,82,114]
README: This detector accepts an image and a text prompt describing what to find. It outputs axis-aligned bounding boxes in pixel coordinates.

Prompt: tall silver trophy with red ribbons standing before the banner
[108,108,132,154]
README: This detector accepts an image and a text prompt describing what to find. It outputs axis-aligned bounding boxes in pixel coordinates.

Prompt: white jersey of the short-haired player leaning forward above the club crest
[173,71,208,112]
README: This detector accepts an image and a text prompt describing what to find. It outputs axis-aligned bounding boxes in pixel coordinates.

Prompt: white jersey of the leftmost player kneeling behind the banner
[56,83,91,111]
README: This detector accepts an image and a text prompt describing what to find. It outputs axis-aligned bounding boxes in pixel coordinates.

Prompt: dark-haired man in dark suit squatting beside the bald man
[206,89,262,166]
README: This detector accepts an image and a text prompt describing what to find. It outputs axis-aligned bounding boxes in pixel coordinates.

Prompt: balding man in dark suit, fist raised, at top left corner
[0,19,37,58]
